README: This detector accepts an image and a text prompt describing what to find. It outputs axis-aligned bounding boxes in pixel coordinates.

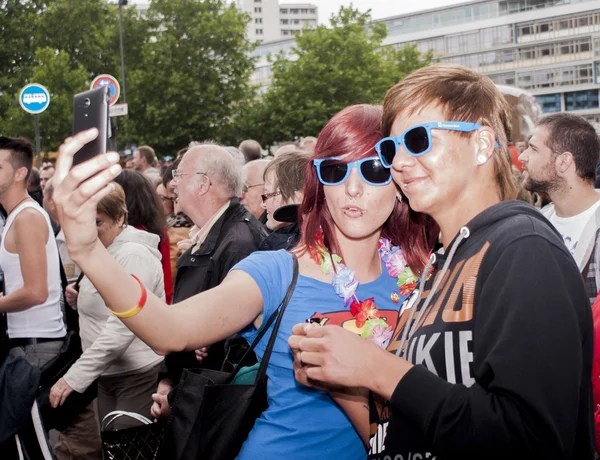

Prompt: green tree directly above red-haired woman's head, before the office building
[238,7,431,145]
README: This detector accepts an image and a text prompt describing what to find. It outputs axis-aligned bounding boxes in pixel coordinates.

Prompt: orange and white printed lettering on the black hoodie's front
[369,243,490,460]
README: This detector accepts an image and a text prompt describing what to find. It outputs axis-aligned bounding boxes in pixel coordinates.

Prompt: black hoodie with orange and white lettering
[369,201,594,460]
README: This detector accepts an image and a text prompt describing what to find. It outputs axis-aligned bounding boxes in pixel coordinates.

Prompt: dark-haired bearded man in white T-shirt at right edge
[519,113,600,304]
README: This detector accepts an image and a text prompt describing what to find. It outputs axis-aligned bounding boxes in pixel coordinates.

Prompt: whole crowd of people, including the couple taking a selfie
[0,64,600,460]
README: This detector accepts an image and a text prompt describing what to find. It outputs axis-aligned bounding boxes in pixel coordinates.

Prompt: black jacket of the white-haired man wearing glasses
[162,198,267,384]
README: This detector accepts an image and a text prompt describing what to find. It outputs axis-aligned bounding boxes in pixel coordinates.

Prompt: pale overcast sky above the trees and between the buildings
[279,0,465,24]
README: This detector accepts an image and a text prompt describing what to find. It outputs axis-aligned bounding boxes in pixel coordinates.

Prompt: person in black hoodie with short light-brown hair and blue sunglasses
[289,64,594,460]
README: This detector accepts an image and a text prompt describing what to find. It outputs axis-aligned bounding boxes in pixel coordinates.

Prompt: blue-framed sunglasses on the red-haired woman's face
[313,157,392,186]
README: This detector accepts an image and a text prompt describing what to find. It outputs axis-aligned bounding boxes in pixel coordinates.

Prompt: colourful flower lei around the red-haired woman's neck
[310,229,418,348]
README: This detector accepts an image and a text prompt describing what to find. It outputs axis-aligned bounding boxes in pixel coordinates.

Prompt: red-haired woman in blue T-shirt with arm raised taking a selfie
[47,105,427,459]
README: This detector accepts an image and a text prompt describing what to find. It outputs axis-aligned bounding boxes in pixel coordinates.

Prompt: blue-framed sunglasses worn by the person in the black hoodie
[375,121,499,168]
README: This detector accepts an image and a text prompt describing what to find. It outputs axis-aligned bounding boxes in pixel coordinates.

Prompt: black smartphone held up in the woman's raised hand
[73,86,110,166]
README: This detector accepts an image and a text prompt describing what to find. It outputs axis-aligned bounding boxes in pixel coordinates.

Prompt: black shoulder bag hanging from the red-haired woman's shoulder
[160,256,298,460]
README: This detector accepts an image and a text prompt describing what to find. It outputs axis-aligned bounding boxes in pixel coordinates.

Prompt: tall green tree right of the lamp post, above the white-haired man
[127,0,254,155]
